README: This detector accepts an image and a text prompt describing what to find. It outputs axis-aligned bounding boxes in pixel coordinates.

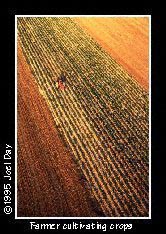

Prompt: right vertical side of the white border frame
[149,15,152,219]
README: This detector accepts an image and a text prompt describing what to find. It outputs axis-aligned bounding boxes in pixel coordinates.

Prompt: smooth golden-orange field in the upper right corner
[73,17,149,91]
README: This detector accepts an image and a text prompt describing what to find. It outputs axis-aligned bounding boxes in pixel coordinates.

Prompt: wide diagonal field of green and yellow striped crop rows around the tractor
[18,18,149,216]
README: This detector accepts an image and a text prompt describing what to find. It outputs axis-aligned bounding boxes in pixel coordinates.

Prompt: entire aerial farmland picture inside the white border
[15,15,151,218]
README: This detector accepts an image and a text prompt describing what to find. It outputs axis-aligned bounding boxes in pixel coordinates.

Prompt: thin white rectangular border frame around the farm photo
[15,15,151,219]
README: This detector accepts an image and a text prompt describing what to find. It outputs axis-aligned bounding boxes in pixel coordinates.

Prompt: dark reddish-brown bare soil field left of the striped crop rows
[17,41,96,217]
